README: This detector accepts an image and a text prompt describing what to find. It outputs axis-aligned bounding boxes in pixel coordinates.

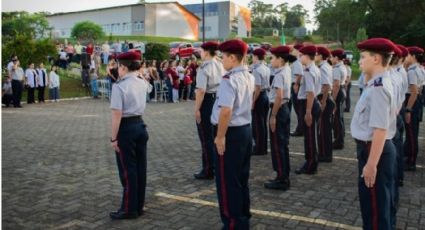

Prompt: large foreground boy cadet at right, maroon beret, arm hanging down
[351,38,396,230]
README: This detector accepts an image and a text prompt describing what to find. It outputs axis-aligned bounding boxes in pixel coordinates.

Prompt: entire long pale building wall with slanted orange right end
[47,3,199,40]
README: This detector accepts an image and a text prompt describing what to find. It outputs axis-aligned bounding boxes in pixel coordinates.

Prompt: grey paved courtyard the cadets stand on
[2,88,425,230]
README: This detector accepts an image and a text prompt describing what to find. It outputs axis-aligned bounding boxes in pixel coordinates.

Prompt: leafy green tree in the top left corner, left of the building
[2,11,52,41]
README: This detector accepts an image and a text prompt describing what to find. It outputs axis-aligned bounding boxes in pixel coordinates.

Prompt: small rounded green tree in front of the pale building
[71,21,105,41]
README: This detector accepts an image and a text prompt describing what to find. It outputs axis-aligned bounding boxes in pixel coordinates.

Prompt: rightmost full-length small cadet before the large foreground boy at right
[331,49,347,149]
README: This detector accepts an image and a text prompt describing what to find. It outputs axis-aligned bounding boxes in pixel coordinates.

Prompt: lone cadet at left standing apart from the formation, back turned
[109,52,152,219]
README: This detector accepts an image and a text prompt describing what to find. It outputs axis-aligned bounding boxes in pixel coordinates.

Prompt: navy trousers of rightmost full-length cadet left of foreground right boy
[333,86,345,145]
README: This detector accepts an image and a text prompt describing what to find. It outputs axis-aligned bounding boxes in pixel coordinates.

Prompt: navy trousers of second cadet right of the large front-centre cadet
[269,103,291,180]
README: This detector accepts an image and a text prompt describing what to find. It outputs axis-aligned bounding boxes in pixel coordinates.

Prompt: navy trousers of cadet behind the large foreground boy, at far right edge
[404,94,421,166]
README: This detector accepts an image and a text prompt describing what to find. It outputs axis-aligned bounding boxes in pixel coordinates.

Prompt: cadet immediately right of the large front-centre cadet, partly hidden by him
[252,48,270,155]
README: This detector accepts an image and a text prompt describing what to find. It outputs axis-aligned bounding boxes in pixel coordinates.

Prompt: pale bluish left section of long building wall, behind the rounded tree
[47,7,134,37]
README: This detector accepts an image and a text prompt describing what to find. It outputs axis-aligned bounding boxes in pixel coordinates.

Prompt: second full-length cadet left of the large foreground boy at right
[315,46,335,162]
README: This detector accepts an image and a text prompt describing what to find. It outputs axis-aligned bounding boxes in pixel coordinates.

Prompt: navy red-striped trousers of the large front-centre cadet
[215,125,252,230]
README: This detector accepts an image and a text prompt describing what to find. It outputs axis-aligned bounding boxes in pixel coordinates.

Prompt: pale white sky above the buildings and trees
[1,0,314,30]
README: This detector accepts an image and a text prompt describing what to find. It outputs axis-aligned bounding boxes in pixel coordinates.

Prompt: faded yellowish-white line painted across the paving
[155,192,361,230]
